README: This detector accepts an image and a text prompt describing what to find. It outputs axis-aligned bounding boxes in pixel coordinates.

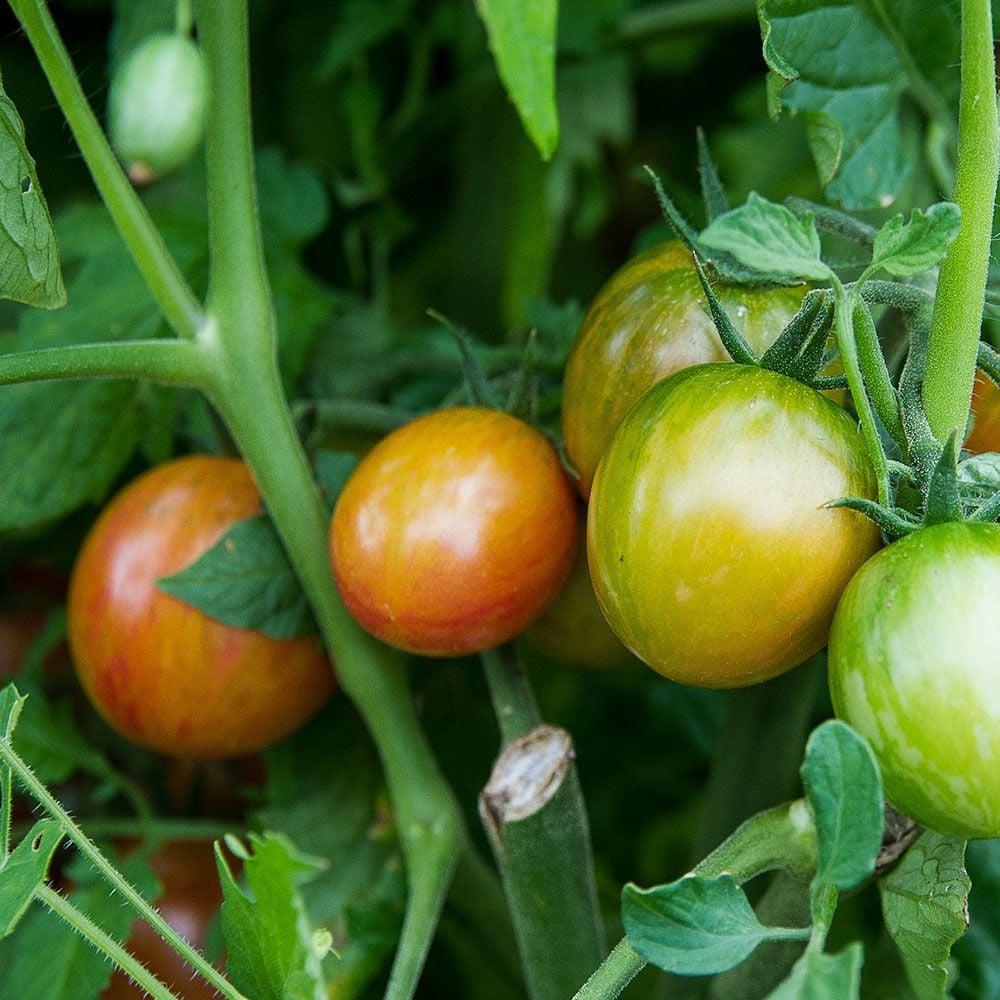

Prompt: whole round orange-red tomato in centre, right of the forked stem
[330,407,577,656]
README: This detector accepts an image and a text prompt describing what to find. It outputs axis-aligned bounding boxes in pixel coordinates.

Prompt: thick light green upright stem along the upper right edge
[922,0,1000,441]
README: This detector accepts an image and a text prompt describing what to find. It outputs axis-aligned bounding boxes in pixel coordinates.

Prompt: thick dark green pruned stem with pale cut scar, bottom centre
[480,646,605,1000]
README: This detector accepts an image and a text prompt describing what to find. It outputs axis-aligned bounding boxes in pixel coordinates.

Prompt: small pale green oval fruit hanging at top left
[108,33,207,184]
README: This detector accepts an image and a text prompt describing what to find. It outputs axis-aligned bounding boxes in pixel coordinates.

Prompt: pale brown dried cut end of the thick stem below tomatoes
[479,725,576,842]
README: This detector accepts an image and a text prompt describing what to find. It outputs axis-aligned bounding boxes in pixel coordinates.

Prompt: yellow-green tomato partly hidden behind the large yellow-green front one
[562,240,807,497]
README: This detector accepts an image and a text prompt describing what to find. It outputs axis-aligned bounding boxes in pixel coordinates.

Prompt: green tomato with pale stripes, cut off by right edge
[829,523,1000,838]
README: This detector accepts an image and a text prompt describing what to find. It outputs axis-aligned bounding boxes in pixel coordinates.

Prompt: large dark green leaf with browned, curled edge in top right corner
[758,0,959,209]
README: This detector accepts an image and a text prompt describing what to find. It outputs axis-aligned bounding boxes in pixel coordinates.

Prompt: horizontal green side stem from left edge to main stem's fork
[0,340,208,386]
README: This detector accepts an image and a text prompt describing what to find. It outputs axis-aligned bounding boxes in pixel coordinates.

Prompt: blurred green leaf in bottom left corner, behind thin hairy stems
[0,857,159,1000]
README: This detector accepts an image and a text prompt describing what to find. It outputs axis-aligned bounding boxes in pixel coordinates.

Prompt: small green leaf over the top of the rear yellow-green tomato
[699,191,830,281]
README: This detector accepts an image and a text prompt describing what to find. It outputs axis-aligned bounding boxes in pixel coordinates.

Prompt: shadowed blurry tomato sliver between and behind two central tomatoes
[524,532,635,667]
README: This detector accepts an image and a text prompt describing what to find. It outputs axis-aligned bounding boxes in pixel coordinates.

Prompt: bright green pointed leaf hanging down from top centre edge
[477,0,559,160]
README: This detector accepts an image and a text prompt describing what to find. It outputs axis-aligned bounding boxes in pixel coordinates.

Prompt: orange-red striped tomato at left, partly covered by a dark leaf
[67,455,333,758]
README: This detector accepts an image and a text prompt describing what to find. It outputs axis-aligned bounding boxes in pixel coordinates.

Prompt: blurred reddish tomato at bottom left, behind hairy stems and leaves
[101,840,222,1000]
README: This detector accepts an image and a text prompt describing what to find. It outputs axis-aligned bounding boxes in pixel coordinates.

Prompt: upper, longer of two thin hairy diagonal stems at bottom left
[0,739,247,1000]
